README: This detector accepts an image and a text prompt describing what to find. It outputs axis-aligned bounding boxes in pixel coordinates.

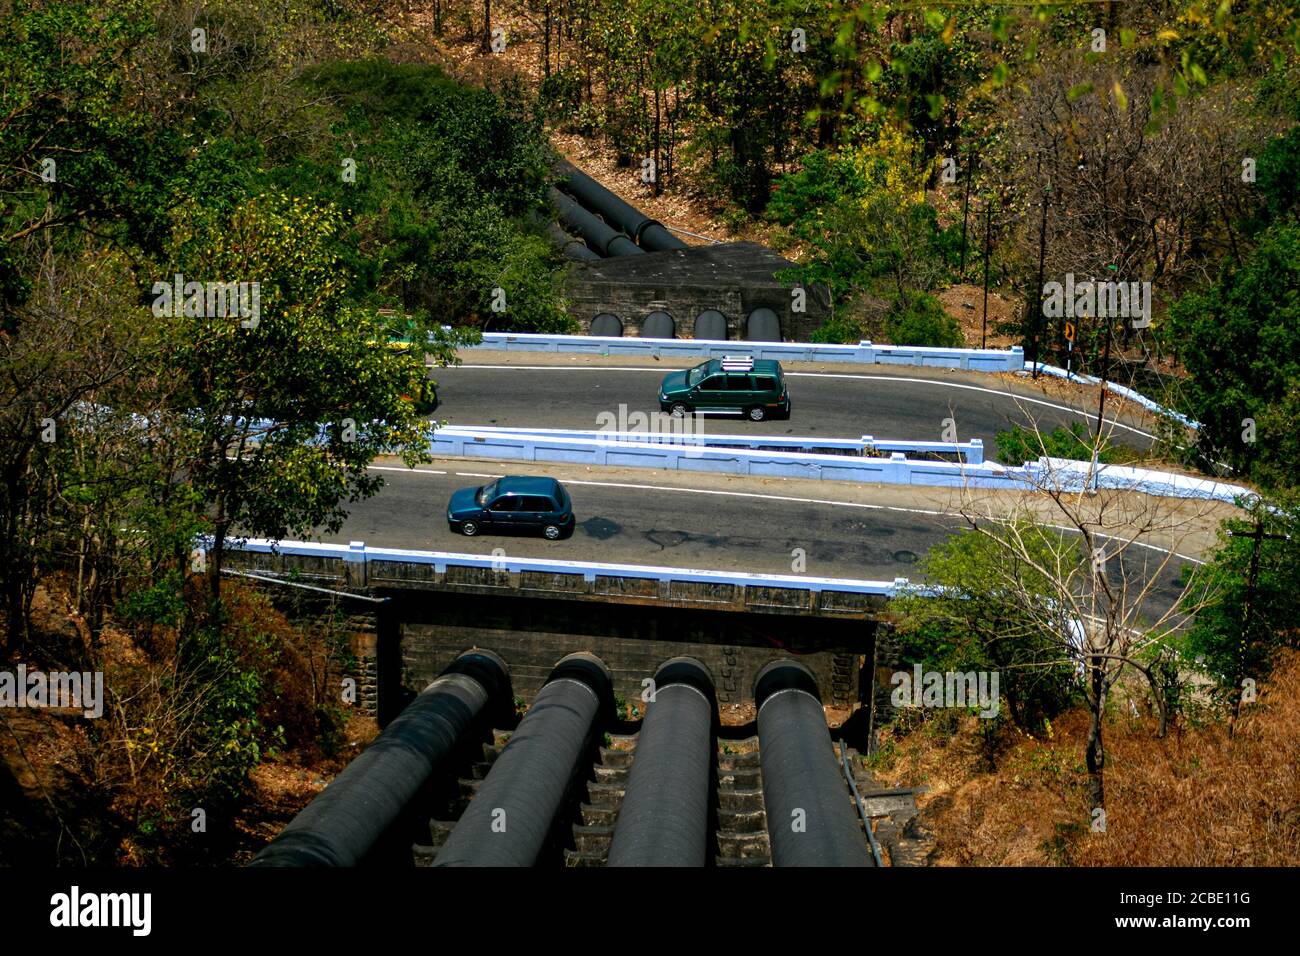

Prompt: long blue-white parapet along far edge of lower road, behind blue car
[430,425,1255,502]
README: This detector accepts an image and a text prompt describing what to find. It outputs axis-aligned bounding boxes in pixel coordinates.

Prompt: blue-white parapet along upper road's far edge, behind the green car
[467,332,1024,372]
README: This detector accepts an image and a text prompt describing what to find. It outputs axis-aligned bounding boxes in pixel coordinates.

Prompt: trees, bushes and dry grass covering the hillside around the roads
[0,0,1300,862]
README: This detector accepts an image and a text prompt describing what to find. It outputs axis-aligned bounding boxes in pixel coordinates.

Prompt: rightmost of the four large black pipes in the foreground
[754,661,872,866]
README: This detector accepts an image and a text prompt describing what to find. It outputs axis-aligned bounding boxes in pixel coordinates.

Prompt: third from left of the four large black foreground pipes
[608,657,718,866]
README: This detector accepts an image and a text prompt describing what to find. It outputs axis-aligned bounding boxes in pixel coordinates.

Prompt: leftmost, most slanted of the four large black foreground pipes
[250,650,512,866]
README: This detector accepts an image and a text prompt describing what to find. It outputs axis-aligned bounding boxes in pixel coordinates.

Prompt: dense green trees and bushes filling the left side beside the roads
[0,0,569,862]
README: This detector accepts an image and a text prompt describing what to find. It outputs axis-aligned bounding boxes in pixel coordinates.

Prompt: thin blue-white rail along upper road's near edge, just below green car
[439,426,984,464]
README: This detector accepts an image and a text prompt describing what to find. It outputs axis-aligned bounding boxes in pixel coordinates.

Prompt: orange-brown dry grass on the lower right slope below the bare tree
[879,650,1300,866]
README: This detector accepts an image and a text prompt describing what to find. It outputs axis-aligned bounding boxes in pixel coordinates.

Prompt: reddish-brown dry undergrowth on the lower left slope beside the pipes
[0,575,366,866]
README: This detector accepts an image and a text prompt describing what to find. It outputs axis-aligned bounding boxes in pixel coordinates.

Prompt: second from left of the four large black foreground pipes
[434,653,612,866]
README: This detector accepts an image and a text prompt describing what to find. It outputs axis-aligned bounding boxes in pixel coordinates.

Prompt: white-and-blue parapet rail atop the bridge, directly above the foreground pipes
[210,537,911,597]
